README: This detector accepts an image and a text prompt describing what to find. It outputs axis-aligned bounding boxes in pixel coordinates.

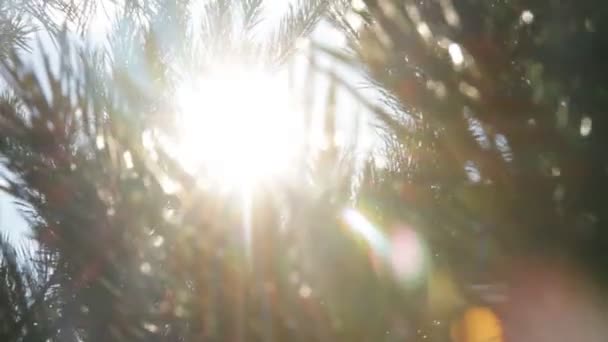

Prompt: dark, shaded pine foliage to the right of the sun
[334,0,607,341]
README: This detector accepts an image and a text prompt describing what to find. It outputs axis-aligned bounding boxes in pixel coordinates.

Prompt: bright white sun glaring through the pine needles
[175,66,303,187]
